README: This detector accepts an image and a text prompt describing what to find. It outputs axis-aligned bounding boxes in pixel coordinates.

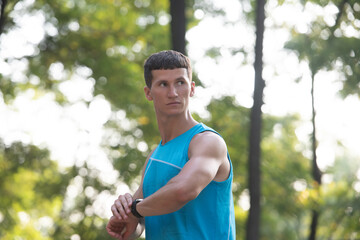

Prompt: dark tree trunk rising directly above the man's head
[170,0,186,54]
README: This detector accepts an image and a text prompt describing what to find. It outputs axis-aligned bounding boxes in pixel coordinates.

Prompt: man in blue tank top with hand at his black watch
[107,51,235,240]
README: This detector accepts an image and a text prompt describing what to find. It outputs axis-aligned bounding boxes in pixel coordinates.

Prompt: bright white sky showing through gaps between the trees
[0,0,360,216]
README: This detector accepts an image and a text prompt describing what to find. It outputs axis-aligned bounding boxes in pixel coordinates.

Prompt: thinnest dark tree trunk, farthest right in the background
[309,74,321,240]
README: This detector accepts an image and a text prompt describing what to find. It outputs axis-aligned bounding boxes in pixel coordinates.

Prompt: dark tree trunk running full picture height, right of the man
[246,0,265,240]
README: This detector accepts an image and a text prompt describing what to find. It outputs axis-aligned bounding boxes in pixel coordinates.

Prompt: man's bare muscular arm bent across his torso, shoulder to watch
[137,132,230,216]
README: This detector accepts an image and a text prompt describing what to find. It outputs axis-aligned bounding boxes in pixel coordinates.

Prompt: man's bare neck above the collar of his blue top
[157,111,198,144]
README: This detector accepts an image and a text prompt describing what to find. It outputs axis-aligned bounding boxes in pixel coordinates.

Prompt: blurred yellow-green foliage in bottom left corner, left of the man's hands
[0,137,124,240]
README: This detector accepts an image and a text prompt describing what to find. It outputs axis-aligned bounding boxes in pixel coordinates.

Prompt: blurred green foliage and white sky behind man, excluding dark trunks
[0,0,360,240]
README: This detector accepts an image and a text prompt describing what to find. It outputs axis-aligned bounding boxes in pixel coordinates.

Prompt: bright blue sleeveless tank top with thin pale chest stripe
[143,123,235,240]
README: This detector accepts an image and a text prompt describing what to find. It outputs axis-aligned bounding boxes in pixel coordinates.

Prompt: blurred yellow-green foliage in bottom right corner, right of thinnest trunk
[319,154,360,239]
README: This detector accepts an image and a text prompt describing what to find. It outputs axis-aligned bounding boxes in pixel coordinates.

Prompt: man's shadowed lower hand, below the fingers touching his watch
[106,216,138,240]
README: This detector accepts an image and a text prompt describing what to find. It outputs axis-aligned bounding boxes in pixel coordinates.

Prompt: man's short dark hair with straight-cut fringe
[144,50,192,88]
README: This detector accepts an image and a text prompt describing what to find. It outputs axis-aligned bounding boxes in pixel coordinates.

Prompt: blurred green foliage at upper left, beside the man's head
[0,0,210,188]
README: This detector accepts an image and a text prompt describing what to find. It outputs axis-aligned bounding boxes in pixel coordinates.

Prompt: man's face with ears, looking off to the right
[144,68,195,115]
